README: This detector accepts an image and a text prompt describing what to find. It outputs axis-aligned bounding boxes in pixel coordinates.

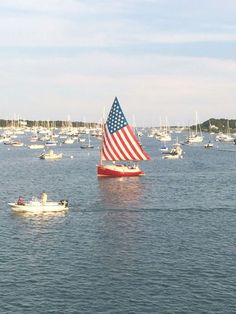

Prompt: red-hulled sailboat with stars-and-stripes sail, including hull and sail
[97,97,151,177]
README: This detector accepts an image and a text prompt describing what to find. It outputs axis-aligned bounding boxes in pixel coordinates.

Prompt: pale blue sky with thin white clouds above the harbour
[0,0,236,126]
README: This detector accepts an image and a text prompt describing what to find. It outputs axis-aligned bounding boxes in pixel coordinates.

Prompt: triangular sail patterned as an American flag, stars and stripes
[101,98,151,161]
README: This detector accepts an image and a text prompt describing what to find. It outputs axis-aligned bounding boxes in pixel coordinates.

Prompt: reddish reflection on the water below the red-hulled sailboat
[98,177,145,209]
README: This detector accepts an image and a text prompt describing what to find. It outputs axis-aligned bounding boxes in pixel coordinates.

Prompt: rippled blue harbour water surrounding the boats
[0,138,236,314]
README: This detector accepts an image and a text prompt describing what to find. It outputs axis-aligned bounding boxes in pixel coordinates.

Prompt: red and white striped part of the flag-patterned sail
[101,125,151,161]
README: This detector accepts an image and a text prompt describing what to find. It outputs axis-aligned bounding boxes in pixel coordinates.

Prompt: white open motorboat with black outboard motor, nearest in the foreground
[8,200,69,214]
